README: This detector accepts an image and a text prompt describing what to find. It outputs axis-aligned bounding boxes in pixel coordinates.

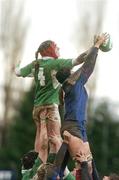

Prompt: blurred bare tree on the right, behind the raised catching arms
[74,0,106,113]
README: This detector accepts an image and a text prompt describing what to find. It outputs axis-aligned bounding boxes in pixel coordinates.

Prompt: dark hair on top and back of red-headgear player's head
[35,40,54,59]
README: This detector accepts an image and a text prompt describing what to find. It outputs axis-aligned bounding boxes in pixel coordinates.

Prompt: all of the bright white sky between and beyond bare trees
[22,0,119,103]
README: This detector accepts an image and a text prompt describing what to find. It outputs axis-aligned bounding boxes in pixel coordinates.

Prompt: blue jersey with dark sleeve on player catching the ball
[63,47,98,141]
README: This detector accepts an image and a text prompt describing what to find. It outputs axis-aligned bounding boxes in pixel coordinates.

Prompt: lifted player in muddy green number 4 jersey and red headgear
[15,40,87,163]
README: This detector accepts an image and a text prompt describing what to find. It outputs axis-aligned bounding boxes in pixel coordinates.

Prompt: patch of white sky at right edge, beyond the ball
[97,0,119,102]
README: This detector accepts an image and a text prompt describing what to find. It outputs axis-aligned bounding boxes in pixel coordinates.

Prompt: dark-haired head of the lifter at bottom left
[21,151,38,169]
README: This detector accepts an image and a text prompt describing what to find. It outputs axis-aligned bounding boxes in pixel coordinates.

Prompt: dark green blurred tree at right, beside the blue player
[88,102,119,178]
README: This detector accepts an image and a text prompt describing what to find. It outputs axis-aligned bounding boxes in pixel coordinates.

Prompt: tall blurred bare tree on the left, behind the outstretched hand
[0,0,28,145]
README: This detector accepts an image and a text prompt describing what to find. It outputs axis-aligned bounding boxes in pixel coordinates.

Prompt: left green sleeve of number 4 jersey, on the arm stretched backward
[20,63,33,77]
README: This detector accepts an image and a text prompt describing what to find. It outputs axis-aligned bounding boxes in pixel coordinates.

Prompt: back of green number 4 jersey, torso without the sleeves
[35,59,60,105]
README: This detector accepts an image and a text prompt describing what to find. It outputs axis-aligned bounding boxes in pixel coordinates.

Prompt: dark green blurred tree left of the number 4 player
[0,88,35,179]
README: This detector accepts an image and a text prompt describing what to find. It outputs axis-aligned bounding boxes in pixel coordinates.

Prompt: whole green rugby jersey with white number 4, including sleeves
[20,58,73,106]
